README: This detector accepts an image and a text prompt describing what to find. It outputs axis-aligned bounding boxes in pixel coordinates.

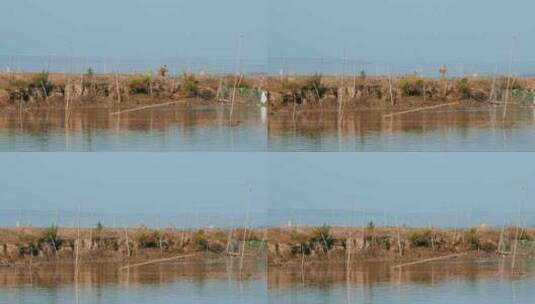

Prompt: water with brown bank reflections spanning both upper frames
[0,104,535,152]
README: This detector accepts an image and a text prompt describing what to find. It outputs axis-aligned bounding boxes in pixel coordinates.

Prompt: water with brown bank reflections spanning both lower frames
[0,259,535,304]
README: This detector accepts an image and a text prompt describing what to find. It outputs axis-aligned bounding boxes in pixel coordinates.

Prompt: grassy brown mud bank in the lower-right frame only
[268,224,535,266]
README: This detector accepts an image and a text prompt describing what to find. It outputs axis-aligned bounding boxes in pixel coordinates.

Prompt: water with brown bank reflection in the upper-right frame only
[268,107,535,151]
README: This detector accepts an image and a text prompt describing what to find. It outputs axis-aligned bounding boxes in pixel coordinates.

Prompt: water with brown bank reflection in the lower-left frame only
[0,259,267,304]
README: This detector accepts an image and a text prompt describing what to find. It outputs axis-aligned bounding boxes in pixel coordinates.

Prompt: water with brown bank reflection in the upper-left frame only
[0,104,267,151]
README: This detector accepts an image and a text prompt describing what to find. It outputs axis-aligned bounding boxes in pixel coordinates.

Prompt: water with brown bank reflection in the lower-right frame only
[268,260,535,303]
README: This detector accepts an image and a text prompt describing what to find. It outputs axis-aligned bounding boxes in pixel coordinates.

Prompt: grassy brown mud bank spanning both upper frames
[0,70,535,113]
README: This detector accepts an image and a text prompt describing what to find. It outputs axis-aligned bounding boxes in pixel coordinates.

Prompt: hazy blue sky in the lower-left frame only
[0,153,267,226]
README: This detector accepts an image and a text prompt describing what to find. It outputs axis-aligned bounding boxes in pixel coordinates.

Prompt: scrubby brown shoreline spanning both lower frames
[0,223,535,267]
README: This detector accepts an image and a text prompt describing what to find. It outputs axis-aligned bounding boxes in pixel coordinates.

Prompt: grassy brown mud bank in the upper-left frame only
[0,71,264,110]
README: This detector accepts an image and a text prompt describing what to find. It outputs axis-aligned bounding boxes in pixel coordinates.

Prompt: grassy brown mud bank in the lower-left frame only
[0,226,266,266]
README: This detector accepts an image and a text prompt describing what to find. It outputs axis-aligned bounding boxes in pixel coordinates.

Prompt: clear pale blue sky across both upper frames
[0,0,535,73]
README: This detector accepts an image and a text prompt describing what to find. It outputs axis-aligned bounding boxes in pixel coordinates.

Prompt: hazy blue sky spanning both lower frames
[0,152,535,225]
